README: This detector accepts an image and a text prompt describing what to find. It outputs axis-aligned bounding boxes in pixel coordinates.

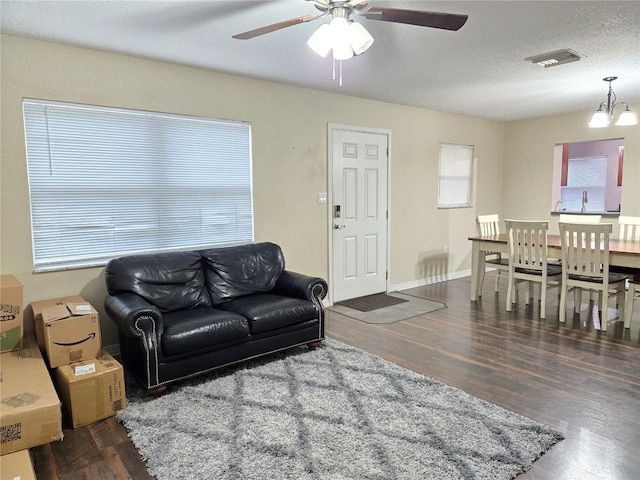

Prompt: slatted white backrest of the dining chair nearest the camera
[559,223,613,282]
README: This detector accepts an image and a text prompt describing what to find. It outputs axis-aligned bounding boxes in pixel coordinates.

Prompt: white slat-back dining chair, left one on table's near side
[504,220,562,318]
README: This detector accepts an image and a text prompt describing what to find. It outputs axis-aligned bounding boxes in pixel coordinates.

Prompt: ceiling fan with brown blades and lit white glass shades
[233,0,468,60]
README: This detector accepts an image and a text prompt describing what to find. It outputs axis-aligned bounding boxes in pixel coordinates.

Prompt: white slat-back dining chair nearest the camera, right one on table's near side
[559,223,628,331]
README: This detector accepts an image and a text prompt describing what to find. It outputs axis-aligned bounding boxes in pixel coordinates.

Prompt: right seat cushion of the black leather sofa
[216,294,318,334]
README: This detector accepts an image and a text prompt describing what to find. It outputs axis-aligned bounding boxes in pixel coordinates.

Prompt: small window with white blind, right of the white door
[438,143,473,208]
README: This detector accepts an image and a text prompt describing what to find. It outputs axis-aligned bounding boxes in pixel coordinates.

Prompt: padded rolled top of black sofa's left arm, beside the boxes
[104,293,164,342]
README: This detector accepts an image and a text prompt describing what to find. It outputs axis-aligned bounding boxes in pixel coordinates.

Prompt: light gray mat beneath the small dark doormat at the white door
[329,292,447,325]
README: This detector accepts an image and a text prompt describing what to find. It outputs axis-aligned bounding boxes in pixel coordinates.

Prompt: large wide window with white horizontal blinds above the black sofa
[23,99,253,271]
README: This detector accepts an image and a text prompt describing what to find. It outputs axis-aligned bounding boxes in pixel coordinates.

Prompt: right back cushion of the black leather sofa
[202,242,284,305]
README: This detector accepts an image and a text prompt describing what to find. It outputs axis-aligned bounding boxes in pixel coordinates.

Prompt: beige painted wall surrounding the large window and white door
[8,35,640,345]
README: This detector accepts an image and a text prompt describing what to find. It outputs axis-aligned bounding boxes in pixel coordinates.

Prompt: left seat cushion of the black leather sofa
[162,308,249,355]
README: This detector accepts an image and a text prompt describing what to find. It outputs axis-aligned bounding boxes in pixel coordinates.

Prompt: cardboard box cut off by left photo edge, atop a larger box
[0,275,23,352]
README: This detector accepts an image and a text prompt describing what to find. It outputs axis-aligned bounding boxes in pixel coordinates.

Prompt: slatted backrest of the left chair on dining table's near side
[504,220,549,272]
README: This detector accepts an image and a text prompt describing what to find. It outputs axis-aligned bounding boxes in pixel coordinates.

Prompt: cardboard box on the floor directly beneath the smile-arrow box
[55,352,126,428]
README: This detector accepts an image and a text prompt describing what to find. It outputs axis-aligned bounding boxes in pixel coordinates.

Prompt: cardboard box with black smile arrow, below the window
[40,302,102,368]
